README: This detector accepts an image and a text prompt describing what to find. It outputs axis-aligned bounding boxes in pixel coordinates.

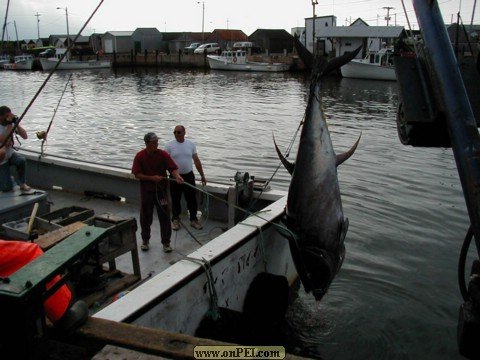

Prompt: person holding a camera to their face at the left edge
[0,106,30,192]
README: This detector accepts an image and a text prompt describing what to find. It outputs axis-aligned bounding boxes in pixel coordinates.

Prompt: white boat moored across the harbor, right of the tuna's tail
[340,48,397,81]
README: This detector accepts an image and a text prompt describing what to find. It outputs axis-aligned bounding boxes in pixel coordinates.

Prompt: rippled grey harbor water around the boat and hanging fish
[0,68,473,360]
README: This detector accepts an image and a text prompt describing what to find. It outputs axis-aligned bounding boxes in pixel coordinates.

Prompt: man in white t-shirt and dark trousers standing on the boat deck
[165,125,207,230]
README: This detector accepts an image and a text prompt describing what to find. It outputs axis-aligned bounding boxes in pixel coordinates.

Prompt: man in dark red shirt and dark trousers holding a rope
[132,132,184,252]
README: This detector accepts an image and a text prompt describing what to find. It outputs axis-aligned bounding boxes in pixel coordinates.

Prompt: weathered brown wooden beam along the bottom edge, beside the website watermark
[76,317,303,360]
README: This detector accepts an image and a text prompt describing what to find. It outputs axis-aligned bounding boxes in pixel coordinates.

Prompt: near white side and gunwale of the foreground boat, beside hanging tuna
[94,199,297,336]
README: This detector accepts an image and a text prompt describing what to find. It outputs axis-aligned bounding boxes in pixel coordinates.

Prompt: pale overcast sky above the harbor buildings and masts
[0,0,480,40]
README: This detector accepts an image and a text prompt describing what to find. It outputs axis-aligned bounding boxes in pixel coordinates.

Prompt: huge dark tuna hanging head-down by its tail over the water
[274,49,360,300]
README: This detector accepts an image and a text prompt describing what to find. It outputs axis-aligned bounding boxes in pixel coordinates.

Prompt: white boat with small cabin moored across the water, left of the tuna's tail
[207,50,290,72]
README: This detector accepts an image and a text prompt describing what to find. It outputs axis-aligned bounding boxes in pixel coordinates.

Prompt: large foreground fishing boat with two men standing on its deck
[0,150,298,358]
